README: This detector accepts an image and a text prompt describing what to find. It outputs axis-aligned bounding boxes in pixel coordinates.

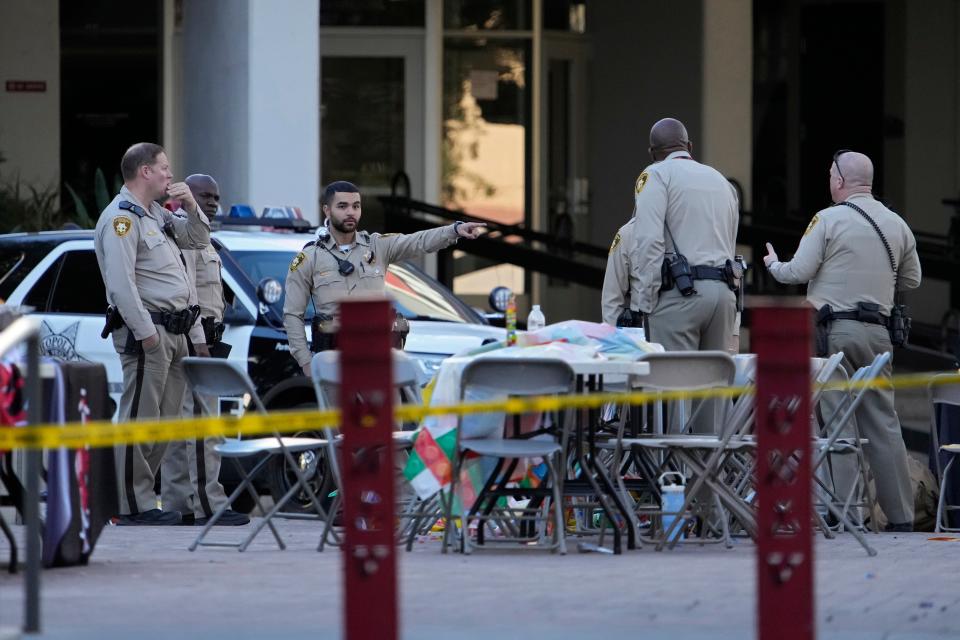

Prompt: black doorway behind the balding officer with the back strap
[753,0,887,218]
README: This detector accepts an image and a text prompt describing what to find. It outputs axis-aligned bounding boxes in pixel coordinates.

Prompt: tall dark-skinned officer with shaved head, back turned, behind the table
[630,118,739,351]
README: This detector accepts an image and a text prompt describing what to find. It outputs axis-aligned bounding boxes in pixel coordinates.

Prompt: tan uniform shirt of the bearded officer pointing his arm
[283,225,457,366]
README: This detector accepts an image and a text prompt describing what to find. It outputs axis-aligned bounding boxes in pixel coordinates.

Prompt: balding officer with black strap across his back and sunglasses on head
[763,151,920,531]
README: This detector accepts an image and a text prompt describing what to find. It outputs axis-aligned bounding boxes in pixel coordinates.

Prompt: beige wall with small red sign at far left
[0,0,60,188]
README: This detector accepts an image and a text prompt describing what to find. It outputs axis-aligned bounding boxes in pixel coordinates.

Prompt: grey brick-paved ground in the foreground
[0,521,960,640]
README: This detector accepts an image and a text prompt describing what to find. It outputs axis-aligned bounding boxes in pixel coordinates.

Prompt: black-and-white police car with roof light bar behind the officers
[0,221,505,508]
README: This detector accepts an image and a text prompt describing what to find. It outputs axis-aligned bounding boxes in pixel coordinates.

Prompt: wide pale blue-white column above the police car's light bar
[184,0,320,222]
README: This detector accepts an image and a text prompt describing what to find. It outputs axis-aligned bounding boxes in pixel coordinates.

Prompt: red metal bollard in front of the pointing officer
[337,299,399,640]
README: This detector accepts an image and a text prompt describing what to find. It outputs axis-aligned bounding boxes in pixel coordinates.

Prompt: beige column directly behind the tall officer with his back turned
[694,0,753,210]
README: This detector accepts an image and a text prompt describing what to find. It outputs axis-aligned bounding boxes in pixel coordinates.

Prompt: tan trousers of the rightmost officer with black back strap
[823,320,913,524]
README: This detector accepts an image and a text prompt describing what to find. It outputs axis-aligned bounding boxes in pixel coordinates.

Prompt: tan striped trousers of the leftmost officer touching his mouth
[113,326,187,515]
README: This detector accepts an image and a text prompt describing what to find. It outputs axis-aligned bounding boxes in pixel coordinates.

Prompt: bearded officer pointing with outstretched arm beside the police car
[283,181,485,376]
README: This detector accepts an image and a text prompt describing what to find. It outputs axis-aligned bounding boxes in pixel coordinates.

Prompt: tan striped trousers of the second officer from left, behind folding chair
[160,388,227,518]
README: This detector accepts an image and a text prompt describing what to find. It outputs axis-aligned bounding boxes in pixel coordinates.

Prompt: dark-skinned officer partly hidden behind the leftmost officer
[160,174,250,526]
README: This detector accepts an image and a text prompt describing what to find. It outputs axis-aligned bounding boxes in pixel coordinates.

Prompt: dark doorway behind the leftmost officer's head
[60,0,162,221]
